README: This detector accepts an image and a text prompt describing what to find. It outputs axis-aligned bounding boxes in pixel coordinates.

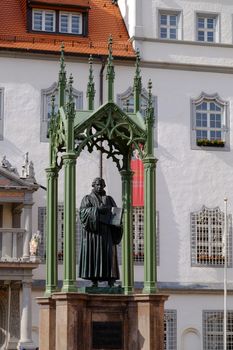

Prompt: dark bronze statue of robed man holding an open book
[79,177,122,287]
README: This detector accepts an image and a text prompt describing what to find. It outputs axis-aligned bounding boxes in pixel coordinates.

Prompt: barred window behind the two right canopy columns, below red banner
[133,207,159,265]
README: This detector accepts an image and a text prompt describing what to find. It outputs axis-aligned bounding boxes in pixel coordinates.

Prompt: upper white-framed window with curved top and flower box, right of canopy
[191,93,230,150]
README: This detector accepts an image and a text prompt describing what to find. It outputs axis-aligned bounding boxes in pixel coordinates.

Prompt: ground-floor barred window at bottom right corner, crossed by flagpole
[202,310,233,350]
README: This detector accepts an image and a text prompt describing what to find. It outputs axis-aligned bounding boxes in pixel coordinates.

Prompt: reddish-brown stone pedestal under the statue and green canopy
[37,293,168,350]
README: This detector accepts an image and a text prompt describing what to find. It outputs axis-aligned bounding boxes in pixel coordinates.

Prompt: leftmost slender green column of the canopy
[45,167,58,295]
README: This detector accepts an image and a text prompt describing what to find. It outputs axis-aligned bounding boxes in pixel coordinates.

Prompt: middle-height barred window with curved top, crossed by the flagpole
[191,206,232,267]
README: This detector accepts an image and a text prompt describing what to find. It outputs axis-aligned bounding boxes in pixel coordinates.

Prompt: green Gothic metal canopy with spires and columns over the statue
[46,37,156,295]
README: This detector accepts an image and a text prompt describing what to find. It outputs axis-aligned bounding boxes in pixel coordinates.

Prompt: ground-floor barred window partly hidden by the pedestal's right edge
[164,310,177,350]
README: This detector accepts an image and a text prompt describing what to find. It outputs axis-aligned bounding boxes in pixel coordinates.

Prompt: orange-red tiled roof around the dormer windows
[0,0,135,58]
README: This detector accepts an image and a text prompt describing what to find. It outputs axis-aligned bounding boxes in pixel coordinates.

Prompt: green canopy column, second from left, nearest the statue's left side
[62,153,77,292]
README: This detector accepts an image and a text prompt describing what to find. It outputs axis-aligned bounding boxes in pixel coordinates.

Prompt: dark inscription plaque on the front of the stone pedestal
[92,321,123,350]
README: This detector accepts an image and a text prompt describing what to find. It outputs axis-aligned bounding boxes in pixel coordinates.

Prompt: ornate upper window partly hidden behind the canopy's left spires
[40,83,83,142]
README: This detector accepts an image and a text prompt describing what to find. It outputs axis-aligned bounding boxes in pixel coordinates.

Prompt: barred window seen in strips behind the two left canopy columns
[38,204,81,262]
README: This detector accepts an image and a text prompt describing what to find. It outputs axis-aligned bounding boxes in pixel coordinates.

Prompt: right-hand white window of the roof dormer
[59,12,82,34]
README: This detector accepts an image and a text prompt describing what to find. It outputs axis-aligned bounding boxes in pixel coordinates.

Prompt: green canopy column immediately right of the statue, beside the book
[120,167,134,294]
